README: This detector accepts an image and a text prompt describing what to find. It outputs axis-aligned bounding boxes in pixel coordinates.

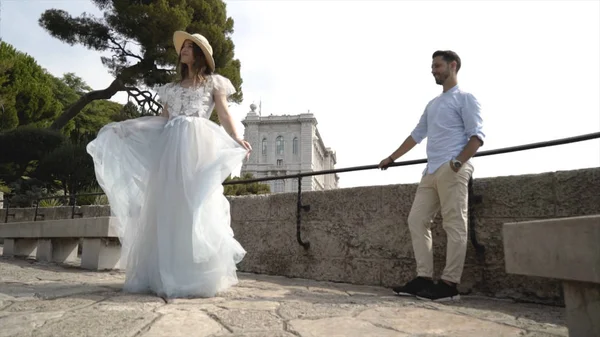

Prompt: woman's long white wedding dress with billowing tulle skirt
[87,75,247,298]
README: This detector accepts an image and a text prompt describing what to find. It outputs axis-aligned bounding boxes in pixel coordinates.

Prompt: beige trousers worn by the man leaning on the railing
[408,162,473,283]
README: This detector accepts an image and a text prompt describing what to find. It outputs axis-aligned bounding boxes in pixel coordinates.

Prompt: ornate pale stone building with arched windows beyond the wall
[241,104,339,193]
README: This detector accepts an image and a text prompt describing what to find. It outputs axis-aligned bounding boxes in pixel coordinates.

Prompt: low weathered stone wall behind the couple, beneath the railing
[0,168,600,305]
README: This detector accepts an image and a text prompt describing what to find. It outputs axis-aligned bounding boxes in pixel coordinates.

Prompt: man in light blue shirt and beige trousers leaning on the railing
[379,50,485,301]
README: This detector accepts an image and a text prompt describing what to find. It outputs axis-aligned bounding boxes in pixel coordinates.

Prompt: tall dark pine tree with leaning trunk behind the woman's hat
[39,0,243,129]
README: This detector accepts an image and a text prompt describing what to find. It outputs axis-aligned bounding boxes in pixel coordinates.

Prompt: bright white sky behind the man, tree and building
[0,0,600,187]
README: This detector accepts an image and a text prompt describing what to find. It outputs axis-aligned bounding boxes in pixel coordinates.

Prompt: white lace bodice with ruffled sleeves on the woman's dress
[155,74,235,119]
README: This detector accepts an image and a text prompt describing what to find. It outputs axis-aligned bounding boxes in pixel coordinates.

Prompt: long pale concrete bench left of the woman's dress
[0,217,121,270]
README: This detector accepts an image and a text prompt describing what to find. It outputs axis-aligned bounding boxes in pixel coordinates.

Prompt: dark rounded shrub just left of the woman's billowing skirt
[35,142,96,194]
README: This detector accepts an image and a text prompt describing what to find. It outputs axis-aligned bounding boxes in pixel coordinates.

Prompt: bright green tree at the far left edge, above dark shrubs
[0,41,62,131]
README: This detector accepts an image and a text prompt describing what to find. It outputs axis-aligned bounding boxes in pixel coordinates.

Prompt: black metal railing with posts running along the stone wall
[0,132,600,254]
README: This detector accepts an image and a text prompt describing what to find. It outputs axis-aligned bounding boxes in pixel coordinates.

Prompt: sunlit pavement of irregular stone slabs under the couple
[0,258,568,337]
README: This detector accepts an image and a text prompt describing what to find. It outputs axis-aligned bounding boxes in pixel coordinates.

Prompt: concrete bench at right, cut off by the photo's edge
[503,215,600,337]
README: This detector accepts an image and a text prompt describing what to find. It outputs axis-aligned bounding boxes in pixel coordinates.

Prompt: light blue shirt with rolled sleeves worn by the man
[411,85,485,174]
